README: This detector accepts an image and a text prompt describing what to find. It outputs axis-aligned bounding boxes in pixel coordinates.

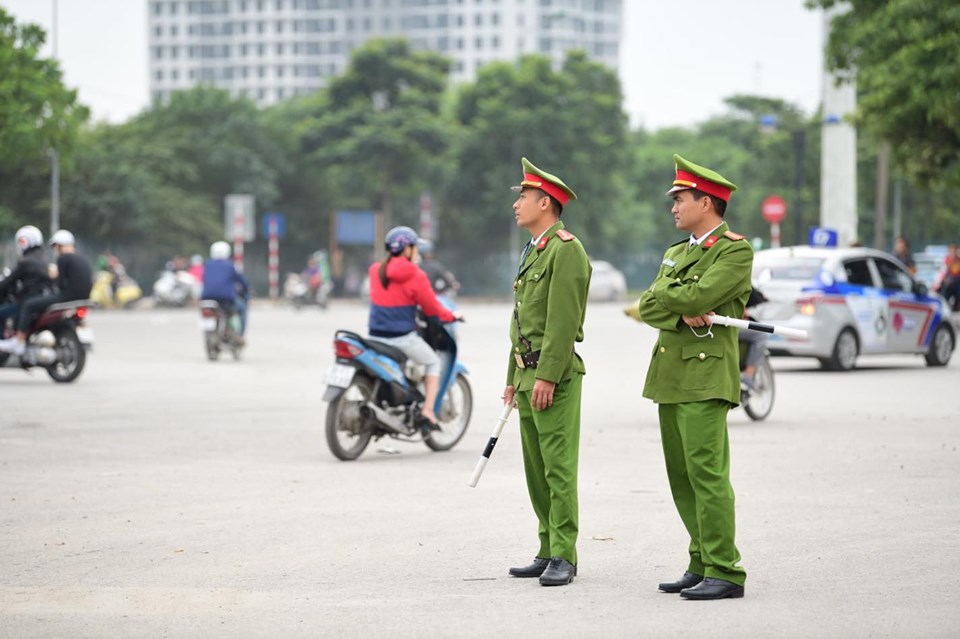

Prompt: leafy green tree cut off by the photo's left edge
[0,7,89,231]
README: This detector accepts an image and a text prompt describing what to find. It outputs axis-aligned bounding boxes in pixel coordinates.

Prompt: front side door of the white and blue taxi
[873,256,933,353]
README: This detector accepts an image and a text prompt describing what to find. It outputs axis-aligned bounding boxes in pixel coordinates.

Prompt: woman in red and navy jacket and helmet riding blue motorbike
[368,226,463,432]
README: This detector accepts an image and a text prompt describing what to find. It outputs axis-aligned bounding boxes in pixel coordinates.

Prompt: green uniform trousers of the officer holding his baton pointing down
[517,374,583,565]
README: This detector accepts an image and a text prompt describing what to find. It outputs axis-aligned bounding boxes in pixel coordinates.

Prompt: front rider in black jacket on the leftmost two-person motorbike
[0,224,51,354]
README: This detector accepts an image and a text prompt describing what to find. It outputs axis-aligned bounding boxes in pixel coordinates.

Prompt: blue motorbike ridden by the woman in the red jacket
[323,301,473,461]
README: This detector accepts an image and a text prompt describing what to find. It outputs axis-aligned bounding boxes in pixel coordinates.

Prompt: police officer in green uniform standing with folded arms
[639,155,753,599]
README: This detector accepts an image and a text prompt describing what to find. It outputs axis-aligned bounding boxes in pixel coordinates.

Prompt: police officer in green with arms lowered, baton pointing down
[503,158,592,586]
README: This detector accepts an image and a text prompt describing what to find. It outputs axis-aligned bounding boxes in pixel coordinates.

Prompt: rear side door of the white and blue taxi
[838,257,890,353]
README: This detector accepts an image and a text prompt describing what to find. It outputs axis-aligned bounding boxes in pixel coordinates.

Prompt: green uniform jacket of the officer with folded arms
[639,222,753,406]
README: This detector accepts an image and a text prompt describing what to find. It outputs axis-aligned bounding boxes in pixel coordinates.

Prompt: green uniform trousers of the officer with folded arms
[659,399,747,586]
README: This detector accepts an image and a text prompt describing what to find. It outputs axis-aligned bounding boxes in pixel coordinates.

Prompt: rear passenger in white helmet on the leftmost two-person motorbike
[0,229,93,355]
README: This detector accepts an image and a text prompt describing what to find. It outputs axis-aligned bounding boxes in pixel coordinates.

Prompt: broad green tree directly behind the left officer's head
[442,52,636,255]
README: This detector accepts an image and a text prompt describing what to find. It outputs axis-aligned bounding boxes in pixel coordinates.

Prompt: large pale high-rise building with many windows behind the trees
[148,0,623,105]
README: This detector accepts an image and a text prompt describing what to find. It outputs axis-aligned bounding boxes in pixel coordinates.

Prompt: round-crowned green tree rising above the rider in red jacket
[299,39,450,238]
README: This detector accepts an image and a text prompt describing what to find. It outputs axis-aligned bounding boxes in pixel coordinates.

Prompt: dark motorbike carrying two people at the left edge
[0,300,93,383]
